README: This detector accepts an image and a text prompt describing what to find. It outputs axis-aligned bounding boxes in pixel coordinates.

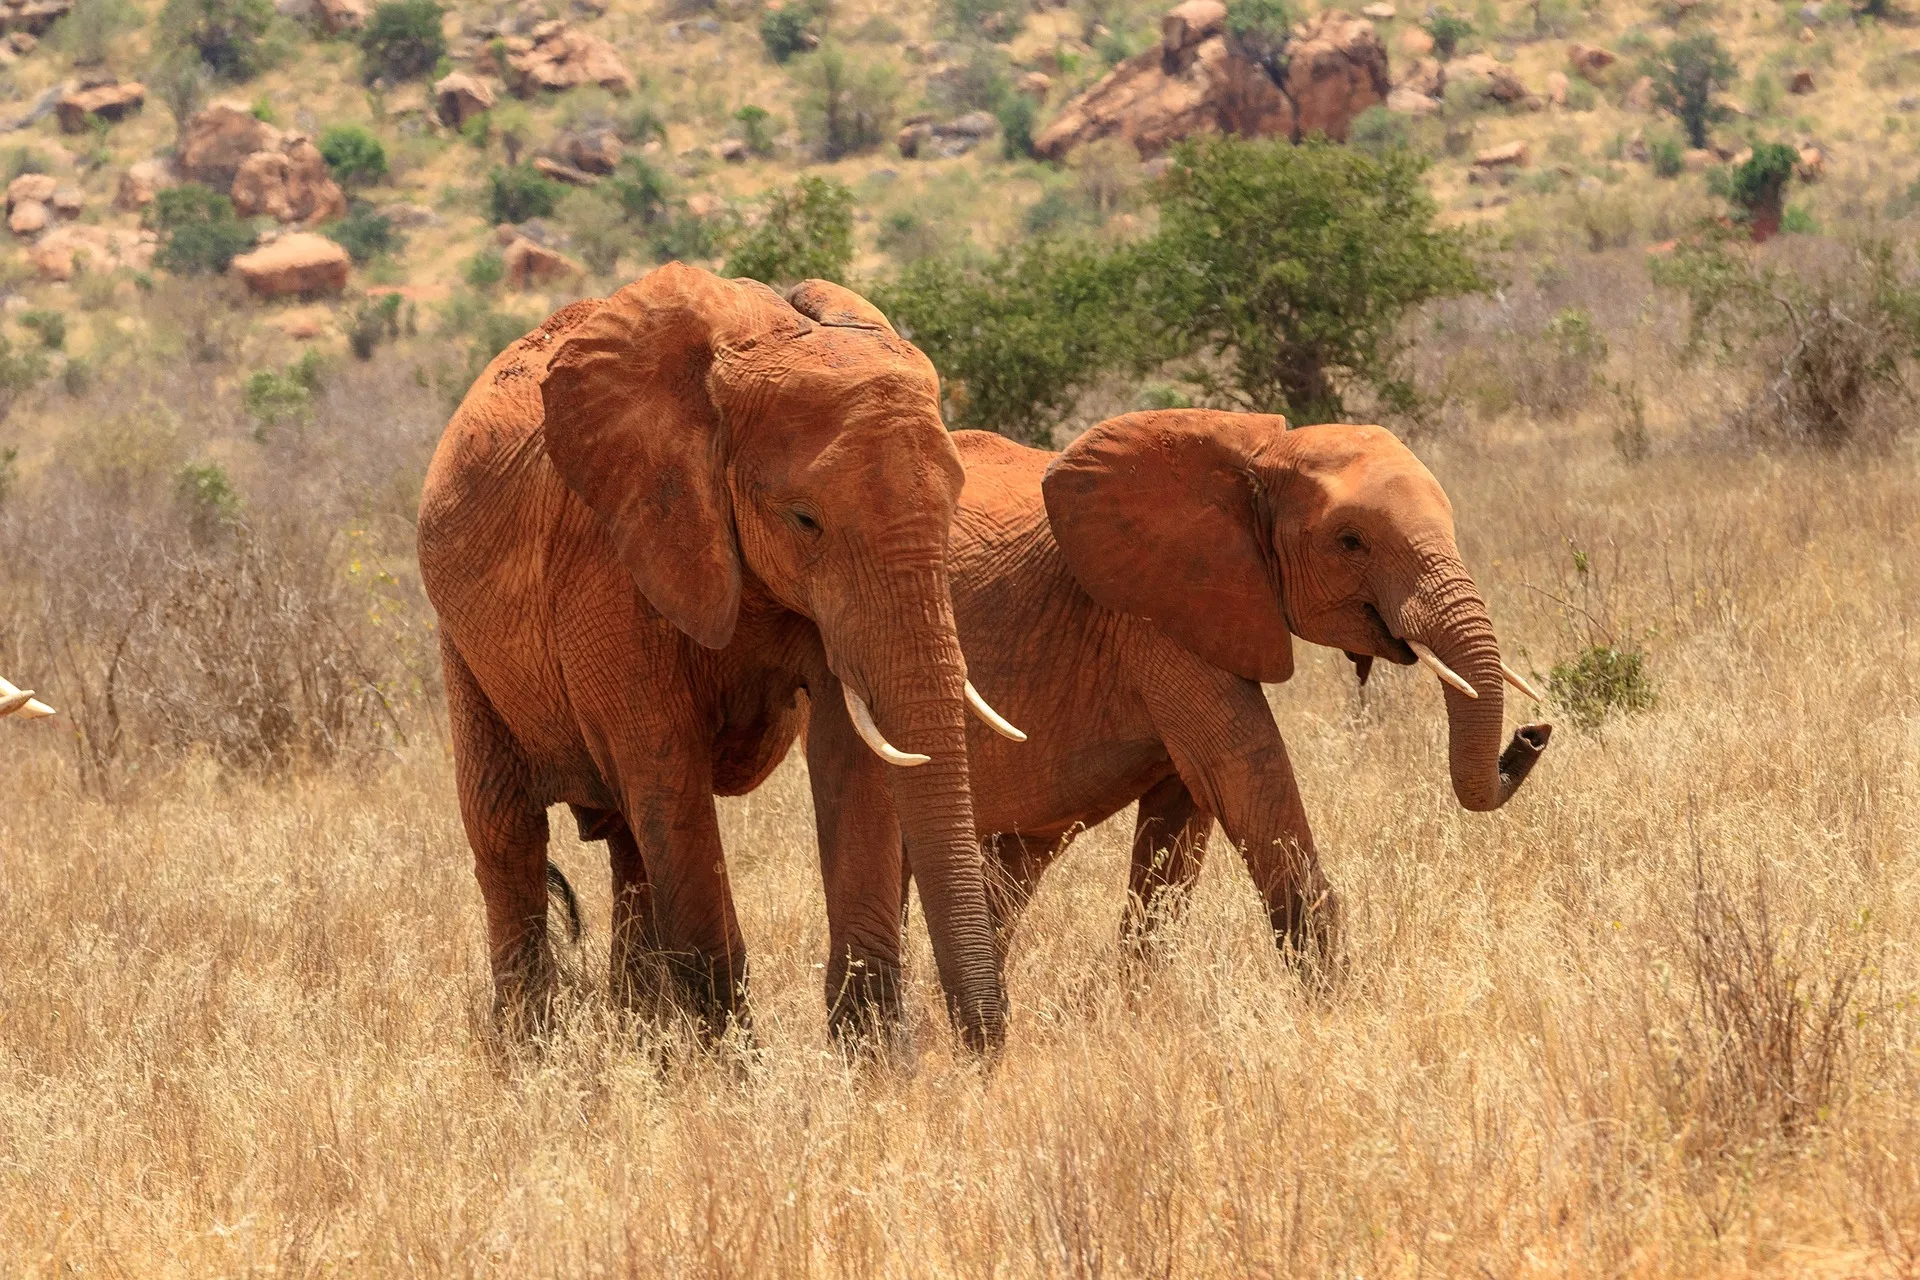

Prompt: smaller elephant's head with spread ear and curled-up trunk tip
[1044,409,1551,810]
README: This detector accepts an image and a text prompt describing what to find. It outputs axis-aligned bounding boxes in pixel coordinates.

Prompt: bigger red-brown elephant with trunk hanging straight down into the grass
[419,265,1004,1046]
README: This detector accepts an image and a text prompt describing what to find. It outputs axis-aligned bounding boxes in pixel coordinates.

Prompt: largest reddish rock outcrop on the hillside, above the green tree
[1033,0,1390,159]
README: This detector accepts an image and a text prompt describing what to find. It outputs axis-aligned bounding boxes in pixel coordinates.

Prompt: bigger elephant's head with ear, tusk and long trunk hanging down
[541,263,1004,1042]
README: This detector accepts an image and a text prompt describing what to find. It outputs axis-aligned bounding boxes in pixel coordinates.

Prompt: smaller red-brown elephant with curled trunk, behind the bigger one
[810,411,1551,971]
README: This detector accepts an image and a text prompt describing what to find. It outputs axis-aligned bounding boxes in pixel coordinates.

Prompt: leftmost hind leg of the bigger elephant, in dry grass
[440,639,553,1031]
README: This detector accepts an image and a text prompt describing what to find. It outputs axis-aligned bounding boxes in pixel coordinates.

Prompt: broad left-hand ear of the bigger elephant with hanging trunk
[540,263,808,649]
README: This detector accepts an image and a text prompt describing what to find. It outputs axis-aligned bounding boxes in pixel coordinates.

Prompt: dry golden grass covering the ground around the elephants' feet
[0,410,1920,1276]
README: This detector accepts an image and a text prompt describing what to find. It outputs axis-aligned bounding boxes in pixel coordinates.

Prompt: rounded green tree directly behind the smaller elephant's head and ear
[1148,138,1488,422]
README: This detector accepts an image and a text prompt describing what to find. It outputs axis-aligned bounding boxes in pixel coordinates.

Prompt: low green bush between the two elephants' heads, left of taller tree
[868,240,1146,445]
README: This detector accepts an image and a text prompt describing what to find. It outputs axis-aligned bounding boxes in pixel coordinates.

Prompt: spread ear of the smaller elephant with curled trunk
[1041,411,1294,683]
